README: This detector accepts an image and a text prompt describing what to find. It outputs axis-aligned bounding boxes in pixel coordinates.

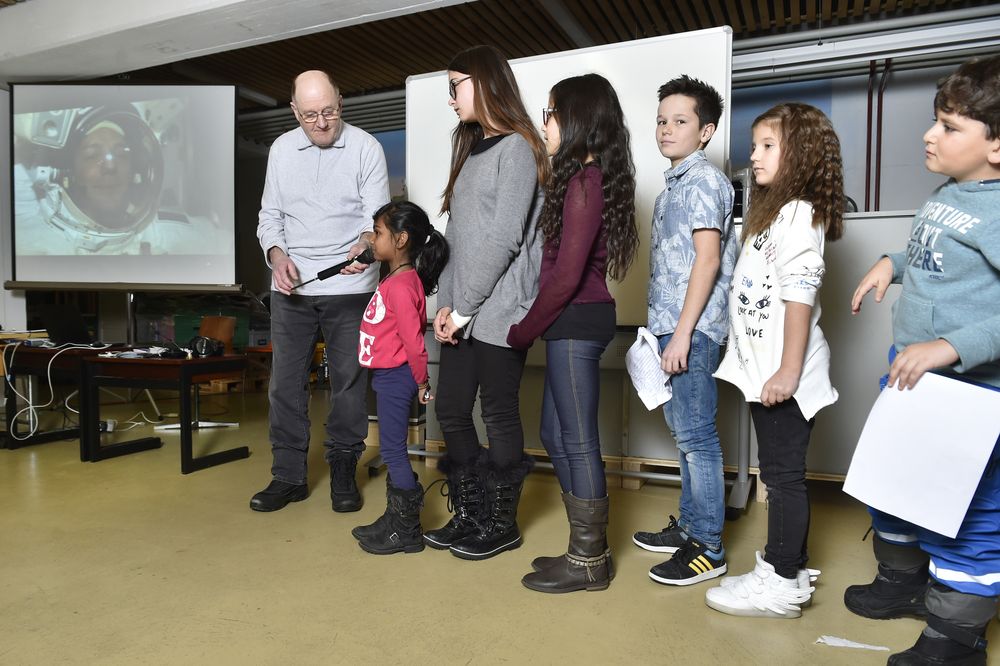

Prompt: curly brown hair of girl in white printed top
[743,102,844,241]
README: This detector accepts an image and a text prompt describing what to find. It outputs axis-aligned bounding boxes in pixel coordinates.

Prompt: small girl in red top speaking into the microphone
[351,201,448,555]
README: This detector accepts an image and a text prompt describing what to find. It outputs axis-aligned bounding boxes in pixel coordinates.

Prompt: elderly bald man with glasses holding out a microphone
[250,71,389,511]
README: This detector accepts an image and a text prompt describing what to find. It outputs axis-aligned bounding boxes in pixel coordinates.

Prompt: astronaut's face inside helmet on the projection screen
[70,126,132,228]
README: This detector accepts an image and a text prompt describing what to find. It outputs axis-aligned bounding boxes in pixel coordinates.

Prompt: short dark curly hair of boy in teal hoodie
[934,55,1000,140]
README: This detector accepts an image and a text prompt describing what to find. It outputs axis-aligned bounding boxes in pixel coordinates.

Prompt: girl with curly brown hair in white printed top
[705,103,844,618]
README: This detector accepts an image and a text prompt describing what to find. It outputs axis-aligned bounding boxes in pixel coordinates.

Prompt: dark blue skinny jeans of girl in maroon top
[540,340,608,499]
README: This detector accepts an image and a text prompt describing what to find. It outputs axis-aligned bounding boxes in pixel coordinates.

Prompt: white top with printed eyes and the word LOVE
[715,201,837,420]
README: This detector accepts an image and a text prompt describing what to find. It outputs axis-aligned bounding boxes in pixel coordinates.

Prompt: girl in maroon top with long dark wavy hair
[507,74,639,592]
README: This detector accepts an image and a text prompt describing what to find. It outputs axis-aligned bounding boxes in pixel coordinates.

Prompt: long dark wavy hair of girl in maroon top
[538,74,639,280]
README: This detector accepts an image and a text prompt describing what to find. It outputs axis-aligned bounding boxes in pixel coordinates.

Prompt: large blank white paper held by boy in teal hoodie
[844,373,1000,537]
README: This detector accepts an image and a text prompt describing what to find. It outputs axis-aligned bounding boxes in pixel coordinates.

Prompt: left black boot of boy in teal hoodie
[844,534,930,620]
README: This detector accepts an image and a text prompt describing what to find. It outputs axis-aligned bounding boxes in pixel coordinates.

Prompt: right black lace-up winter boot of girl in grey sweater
[449,456,534,560]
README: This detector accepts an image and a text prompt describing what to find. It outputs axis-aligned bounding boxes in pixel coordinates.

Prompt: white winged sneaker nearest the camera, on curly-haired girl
[705,551,818,619]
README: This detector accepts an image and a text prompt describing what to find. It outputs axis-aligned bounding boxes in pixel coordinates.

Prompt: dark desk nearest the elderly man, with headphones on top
[80,355,250,474]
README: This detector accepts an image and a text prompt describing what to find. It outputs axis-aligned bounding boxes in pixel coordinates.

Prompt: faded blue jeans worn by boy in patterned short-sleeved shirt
[659,331,726,550]
